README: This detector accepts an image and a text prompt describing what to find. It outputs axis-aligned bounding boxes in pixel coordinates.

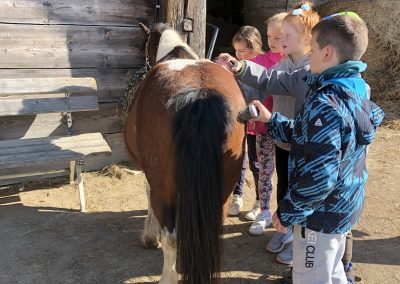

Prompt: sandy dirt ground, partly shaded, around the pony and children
[0,127,400,284]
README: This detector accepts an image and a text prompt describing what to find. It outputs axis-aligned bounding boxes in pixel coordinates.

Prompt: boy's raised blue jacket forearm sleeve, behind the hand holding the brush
[267,112,294,143]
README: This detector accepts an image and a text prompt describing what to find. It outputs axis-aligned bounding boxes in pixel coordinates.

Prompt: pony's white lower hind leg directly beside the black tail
[160,228,179,284]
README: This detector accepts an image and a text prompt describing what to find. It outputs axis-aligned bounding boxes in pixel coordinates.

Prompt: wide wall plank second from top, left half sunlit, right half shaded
[0,24,145,68]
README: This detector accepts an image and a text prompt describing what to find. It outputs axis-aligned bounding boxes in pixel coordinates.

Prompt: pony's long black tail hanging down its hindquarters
[172,89,231,284]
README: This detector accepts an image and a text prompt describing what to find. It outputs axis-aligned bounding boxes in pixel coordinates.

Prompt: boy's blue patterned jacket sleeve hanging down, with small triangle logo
[277,98,343,227]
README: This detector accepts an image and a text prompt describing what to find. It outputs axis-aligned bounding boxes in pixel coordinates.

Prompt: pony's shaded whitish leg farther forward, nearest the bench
[142,184,161,248]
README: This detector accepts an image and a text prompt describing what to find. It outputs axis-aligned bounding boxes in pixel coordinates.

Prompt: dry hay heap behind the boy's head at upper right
[318,0,400,126]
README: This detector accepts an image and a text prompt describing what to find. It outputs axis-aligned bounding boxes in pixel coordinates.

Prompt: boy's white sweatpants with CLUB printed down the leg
[293,225,347,284]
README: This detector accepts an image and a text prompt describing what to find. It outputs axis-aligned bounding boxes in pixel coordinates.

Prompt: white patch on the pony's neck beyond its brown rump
[156,30,199,62]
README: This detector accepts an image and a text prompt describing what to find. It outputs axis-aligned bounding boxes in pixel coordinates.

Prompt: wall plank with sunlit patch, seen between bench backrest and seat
[0,103,124,140]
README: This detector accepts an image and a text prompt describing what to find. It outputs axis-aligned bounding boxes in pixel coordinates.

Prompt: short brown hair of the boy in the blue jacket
[312,15,368,63]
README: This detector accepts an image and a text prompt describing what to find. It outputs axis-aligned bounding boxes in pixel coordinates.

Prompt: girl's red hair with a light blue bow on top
[284,2,320,35]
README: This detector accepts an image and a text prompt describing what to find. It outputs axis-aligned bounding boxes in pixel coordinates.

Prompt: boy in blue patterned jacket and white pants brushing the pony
[245,12,384,284]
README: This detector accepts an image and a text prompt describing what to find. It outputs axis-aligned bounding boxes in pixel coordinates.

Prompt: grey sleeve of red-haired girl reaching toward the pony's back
[236,60,309,101]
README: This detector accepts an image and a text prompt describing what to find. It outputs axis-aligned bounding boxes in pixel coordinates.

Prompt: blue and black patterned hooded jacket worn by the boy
[267,61,384,234]
